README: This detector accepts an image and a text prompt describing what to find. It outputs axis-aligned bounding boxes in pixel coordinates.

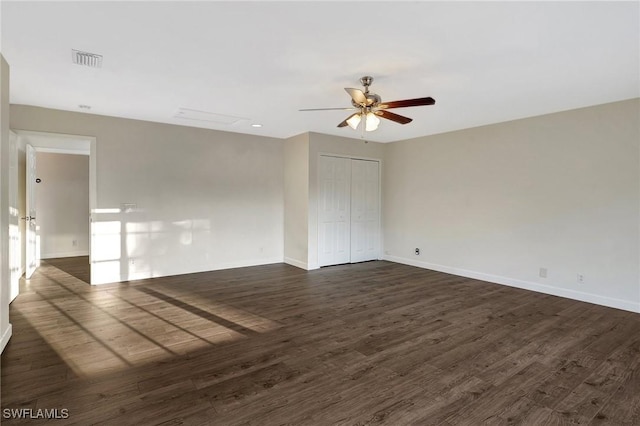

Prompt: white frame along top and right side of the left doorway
[13,130,98,282]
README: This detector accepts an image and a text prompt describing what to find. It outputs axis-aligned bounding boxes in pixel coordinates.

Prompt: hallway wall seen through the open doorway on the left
[35,152,89,259]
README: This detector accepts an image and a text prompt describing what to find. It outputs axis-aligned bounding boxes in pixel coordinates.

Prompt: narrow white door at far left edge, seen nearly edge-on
[9,132,22,302]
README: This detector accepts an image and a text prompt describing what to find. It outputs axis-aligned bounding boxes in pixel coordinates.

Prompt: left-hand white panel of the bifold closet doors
[318,155,351,266]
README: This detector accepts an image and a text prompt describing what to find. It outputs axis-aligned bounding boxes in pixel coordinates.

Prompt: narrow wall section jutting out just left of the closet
[284,133,309,269]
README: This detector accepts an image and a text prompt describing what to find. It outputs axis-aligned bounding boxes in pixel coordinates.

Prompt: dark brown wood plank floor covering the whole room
[1,258,640,425]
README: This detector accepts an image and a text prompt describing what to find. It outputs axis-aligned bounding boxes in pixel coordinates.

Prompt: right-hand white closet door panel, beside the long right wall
[351,160,380,263]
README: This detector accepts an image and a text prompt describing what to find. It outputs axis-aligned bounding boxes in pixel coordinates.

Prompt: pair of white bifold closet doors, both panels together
[318,155,380,266]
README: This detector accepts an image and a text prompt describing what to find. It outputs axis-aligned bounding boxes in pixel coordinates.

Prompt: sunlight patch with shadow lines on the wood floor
[16,269,279,377]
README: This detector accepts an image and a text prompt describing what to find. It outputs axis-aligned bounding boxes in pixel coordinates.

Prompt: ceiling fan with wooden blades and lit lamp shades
[300,75,436,132]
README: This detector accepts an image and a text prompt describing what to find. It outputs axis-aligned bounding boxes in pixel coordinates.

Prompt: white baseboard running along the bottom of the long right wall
[384,255,640,313]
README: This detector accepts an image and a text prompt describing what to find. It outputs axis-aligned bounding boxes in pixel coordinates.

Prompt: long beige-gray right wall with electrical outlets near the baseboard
[383,99,640,312]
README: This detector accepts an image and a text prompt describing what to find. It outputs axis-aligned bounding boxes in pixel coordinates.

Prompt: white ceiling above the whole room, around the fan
[1,1,640,142]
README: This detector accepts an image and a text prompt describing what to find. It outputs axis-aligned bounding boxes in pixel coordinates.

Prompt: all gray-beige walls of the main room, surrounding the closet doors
[6,99,640,311]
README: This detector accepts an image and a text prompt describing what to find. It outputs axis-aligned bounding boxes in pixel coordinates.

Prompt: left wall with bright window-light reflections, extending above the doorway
[11,105,284,284]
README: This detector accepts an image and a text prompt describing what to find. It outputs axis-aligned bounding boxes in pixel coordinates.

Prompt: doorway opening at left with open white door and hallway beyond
[11,130,97,295]
